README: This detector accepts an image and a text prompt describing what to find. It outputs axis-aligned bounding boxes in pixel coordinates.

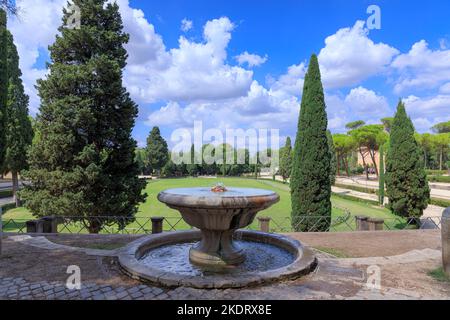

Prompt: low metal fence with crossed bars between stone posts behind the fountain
[3,213,441,234]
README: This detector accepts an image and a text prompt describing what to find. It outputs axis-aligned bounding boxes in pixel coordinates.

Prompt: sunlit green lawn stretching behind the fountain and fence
[3,178,400,232]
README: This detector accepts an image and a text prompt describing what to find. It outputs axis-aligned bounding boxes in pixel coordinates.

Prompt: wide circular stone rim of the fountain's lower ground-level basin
[118,230,318,289]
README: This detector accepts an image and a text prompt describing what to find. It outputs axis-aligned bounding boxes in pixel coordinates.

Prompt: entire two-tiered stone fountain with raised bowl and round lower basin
[119,186,317,288]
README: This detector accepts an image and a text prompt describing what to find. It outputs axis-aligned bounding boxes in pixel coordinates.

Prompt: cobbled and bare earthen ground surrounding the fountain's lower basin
[0,231,450,300]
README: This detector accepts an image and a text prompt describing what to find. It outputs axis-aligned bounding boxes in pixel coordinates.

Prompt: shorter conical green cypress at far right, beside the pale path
[386,101,430,218]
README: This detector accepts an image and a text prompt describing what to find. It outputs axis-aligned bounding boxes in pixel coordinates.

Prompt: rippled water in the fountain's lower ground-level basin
[140,241,295,277]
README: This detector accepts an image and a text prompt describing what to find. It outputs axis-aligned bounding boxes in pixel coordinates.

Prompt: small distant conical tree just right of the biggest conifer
[147,127,169,175]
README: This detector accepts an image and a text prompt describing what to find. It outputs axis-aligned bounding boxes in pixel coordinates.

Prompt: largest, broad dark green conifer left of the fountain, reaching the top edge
[21,0,146,233]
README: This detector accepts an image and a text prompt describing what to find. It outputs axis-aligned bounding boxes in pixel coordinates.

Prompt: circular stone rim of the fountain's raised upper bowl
[157,187,280,209]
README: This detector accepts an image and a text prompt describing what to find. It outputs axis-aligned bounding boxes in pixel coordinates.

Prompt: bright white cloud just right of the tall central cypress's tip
[319,21,399,89]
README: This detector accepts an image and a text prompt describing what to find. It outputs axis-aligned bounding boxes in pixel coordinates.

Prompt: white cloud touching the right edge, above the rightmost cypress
[392,40,450,93]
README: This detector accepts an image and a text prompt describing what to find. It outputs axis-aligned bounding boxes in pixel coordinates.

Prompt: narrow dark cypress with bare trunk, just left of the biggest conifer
[4,32,33,207]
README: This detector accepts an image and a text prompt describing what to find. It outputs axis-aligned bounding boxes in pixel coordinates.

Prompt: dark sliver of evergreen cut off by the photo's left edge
[0,8,8,168]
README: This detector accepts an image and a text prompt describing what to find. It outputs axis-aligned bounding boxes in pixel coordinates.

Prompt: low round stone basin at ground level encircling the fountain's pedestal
[118,231,317,289]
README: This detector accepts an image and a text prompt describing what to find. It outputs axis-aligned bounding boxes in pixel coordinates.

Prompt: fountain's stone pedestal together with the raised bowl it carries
[158,188,279,268]
